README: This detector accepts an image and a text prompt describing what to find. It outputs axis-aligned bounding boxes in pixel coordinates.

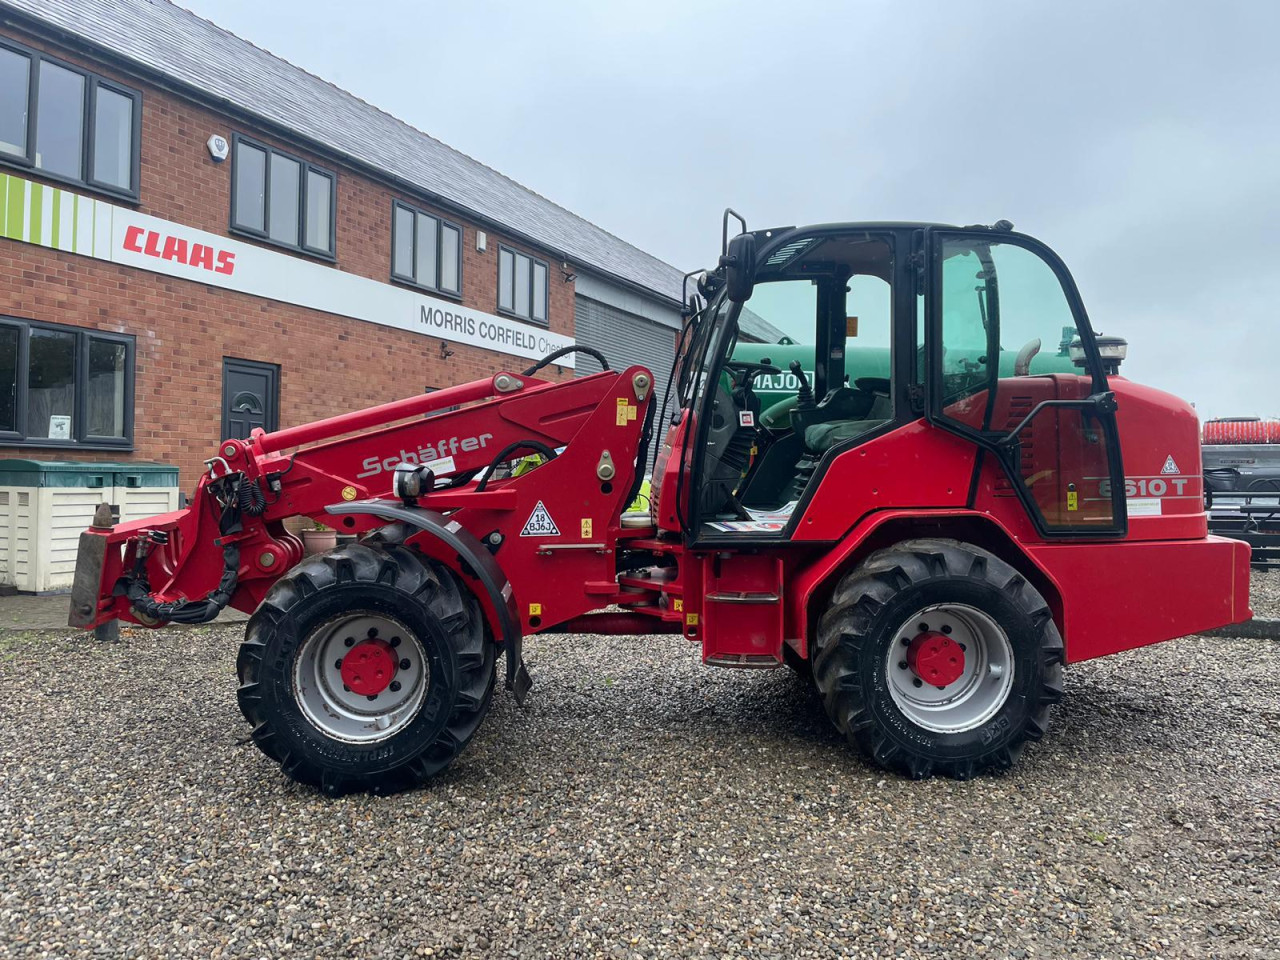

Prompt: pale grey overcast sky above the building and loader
[180,0,1280,417]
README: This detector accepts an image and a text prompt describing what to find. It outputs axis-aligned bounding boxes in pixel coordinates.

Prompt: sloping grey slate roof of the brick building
[0,0,777,340]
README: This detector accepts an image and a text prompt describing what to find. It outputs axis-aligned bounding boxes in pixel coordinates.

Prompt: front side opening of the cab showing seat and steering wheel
[699,232,893,534]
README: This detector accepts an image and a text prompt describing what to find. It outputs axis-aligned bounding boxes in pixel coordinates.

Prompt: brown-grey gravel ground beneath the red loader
[0,611,1280,959]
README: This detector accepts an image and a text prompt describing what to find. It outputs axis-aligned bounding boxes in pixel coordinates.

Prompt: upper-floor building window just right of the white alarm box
[232,137,337,259]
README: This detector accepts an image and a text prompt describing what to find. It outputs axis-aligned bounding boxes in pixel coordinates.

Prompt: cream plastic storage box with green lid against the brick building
[0,460,178,594]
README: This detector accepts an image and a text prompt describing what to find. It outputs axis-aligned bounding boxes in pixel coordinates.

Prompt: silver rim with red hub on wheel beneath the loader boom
[293,612,431,744]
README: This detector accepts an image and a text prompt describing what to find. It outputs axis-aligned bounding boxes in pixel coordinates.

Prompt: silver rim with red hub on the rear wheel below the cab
[884,603,1014,733]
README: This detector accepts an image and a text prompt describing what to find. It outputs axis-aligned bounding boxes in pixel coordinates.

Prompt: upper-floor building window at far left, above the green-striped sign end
[0,41,142,200]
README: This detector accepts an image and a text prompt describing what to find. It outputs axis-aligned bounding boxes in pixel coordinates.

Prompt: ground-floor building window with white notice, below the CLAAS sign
[0,317,133,448]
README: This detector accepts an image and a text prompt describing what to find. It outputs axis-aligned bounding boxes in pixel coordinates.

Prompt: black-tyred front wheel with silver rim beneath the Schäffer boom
[236,538,494,796]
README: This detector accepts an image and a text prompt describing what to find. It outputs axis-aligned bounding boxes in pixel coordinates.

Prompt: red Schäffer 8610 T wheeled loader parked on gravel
[72,211,1251,795]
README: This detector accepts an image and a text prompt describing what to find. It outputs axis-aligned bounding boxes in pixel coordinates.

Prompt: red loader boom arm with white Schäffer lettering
[72,367,653,675]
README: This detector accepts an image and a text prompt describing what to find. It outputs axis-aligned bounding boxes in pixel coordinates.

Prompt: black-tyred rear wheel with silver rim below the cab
[812,540,1064,780]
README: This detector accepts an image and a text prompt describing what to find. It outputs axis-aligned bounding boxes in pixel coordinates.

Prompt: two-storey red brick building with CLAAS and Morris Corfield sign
[0,0,767,489]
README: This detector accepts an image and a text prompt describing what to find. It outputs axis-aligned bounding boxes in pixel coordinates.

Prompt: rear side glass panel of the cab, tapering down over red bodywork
[925,228,1128,538]
